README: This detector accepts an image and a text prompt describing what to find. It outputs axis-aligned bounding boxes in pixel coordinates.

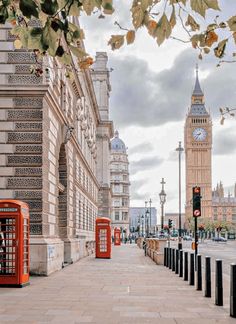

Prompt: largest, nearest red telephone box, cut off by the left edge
[0,200,29,287]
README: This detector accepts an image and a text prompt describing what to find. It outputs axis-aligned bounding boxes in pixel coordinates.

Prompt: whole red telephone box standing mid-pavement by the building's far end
[96,217,111,259]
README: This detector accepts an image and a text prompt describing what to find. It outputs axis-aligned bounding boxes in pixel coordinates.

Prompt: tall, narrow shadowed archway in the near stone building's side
[58,144,68,262]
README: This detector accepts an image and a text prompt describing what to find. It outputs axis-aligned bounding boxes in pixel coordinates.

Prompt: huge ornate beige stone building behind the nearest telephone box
[0,26,112,275]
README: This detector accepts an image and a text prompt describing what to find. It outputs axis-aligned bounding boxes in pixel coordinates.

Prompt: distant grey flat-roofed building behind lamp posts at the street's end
[130,207,157,234]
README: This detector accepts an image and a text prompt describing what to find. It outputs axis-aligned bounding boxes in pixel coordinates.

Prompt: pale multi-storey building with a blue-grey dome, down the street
[110,131,130,237]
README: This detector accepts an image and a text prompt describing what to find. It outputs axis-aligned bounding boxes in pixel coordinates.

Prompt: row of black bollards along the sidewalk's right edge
[164,247,236,318]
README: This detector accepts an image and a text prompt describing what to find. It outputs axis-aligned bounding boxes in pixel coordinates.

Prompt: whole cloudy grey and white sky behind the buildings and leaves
[82,0,236,221]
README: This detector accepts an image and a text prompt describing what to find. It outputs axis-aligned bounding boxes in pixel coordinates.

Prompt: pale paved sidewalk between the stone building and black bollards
[0,244,236,324]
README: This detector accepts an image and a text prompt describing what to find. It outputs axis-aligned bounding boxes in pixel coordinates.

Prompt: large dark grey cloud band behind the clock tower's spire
[110,49,236,127]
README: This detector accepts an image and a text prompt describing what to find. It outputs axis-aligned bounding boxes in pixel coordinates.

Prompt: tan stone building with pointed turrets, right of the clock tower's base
[212,182,236,224]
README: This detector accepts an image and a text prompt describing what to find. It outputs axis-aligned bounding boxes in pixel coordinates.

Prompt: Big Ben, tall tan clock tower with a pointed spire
[184,68,212,222]
